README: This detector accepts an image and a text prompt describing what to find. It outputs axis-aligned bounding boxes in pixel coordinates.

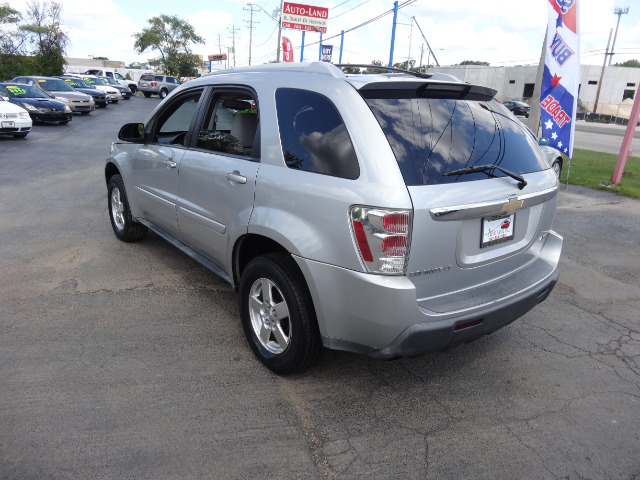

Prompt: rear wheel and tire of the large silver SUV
[239,253,322,375]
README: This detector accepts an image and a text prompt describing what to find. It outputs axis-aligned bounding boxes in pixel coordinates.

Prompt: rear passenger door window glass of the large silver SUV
[196,90,260,158]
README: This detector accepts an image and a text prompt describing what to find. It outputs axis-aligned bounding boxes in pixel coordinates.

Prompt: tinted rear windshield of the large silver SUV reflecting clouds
[366,98,548,185]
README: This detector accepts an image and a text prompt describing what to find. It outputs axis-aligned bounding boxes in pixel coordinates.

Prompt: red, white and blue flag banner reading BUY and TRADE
[540,0,580,157]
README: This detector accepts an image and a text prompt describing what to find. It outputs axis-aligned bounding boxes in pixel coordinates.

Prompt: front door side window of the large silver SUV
[152,90,202,145]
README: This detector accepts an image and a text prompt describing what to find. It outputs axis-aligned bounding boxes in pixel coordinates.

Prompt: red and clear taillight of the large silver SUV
[350,207,411,275]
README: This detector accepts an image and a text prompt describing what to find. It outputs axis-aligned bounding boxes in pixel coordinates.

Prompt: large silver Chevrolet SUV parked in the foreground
[105,62,562,374]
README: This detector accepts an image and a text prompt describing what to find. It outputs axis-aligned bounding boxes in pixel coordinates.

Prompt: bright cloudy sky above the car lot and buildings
[5,0,640,66]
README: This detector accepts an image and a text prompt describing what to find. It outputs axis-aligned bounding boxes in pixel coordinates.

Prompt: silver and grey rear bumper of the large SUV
[296,232,562,358]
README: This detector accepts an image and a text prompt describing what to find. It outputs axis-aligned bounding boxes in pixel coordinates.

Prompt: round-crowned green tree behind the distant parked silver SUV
[133,15,204,76]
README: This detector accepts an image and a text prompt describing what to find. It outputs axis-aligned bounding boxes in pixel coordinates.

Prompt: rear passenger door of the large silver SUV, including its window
[177,87,260,272]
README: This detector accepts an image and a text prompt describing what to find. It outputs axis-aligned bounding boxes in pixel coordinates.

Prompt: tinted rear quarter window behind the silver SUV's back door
[276,88,360,180]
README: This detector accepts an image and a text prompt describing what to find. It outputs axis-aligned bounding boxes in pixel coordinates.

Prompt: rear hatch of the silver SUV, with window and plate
[359,80,557,315]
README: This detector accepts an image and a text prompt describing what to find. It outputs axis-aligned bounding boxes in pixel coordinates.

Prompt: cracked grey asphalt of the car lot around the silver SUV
[0,97,640,480]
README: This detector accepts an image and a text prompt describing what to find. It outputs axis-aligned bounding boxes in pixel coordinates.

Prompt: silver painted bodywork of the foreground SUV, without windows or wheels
[108,63,562,358]
